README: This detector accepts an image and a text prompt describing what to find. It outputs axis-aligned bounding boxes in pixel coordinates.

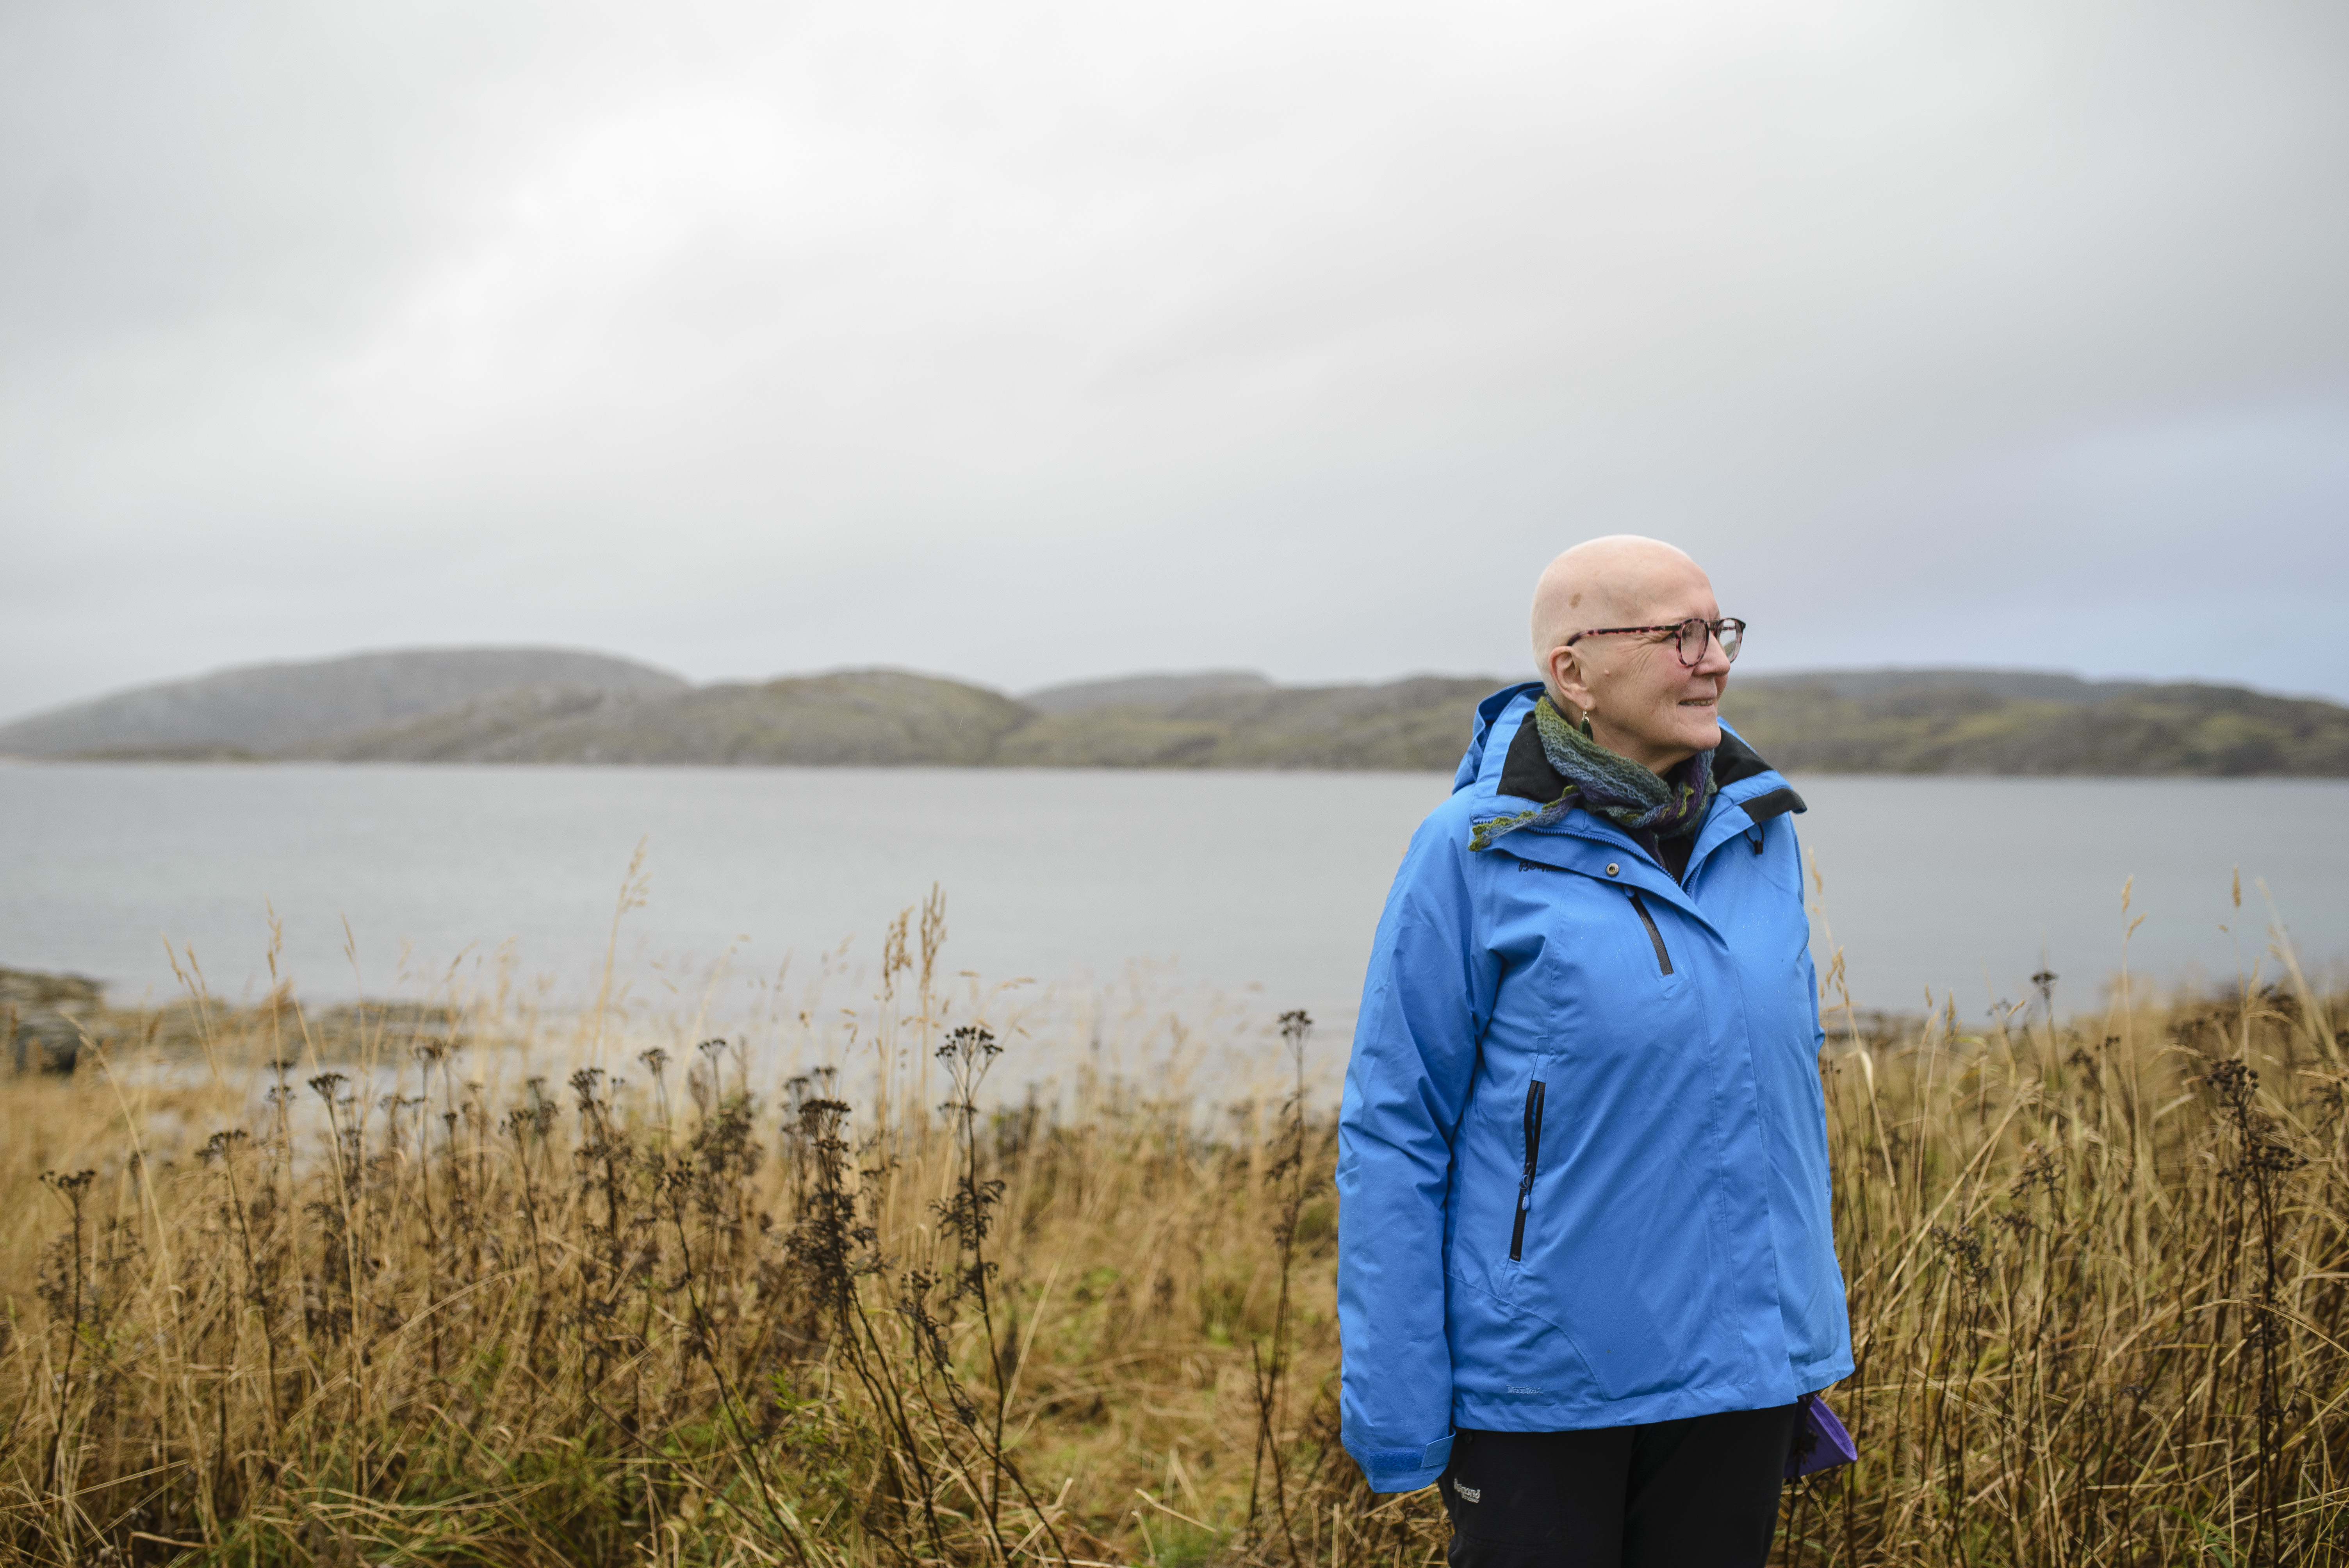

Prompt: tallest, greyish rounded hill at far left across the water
[0,648,688,758]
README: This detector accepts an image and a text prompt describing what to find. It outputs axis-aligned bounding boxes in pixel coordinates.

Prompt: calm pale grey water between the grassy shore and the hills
[0,765,2349,1037]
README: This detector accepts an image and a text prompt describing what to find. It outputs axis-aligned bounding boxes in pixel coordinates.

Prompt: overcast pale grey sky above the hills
[0,0,2349,714]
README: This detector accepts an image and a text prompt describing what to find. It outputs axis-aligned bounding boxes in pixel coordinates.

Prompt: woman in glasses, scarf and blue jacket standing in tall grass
[1337,538,1851,1568]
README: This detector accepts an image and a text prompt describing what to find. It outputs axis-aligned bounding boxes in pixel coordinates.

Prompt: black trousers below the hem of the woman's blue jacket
[1438,1404,1802,1568]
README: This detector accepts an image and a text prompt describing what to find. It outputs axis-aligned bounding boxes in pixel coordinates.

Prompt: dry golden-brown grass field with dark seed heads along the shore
[0,887,2349,1568]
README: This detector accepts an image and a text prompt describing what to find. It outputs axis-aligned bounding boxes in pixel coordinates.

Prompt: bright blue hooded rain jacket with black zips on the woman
[1337,685,1851,1491]
